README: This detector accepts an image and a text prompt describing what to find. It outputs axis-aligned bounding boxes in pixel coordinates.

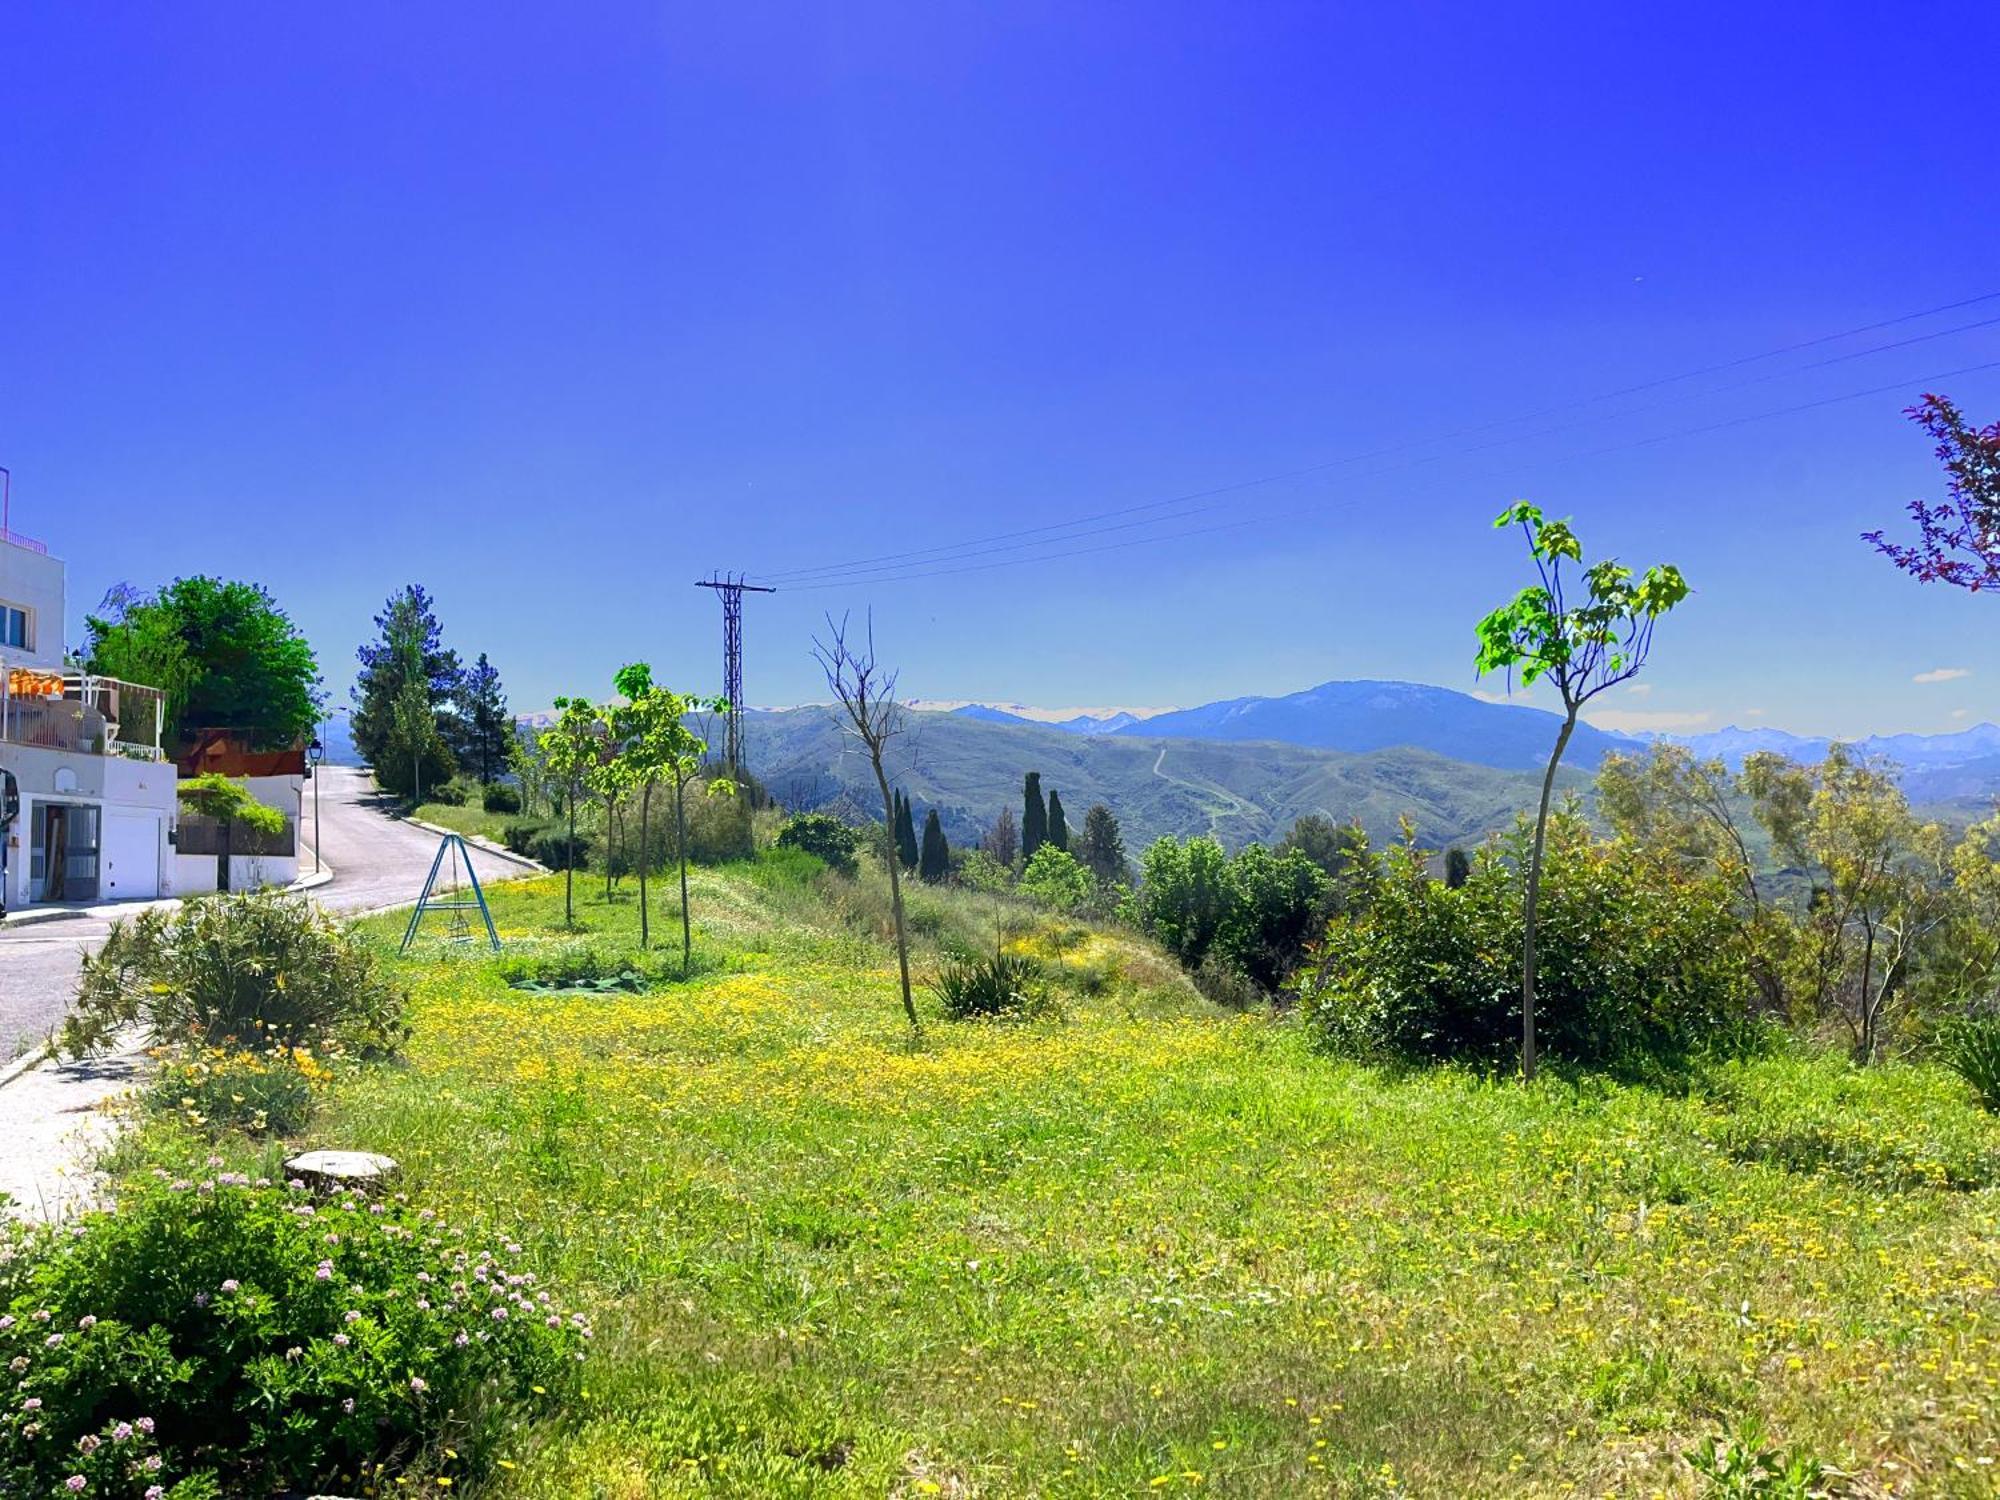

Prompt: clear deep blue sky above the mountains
[0,2,2000,734]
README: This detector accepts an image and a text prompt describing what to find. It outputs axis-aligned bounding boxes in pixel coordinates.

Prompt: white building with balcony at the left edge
[0,530,178,910]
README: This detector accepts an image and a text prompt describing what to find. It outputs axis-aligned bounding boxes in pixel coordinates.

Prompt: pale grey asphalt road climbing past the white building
[0,766,526,1066]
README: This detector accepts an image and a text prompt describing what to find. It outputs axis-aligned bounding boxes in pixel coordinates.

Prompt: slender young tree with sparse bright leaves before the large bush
[1476,500,1688,1080]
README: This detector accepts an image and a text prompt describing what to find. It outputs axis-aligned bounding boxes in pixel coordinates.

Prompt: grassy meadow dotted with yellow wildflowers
[125,860,2000,1500]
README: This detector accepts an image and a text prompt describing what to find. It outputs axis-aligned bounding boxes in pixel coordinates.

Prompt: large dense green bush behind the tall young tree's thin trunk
[1298,818,1750,1068]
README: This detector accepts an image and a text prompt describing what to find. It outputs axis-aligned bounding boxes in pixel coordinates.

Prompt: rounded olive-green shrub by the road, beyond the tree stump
[62,892,408,1056]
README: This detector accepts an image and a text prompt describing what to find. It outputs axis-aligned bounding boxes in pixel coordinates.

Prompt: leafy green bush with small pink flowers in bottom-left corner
[0,1184,590,1500]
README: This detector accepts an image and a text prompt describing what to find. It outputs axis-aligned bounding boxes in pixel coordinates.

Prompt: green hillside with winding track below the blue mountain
[746,708,1586,850]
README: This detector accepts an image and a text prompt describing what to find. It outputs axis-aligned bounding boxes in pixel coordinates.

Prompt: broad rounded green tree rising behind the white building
[84,578,320,750]
